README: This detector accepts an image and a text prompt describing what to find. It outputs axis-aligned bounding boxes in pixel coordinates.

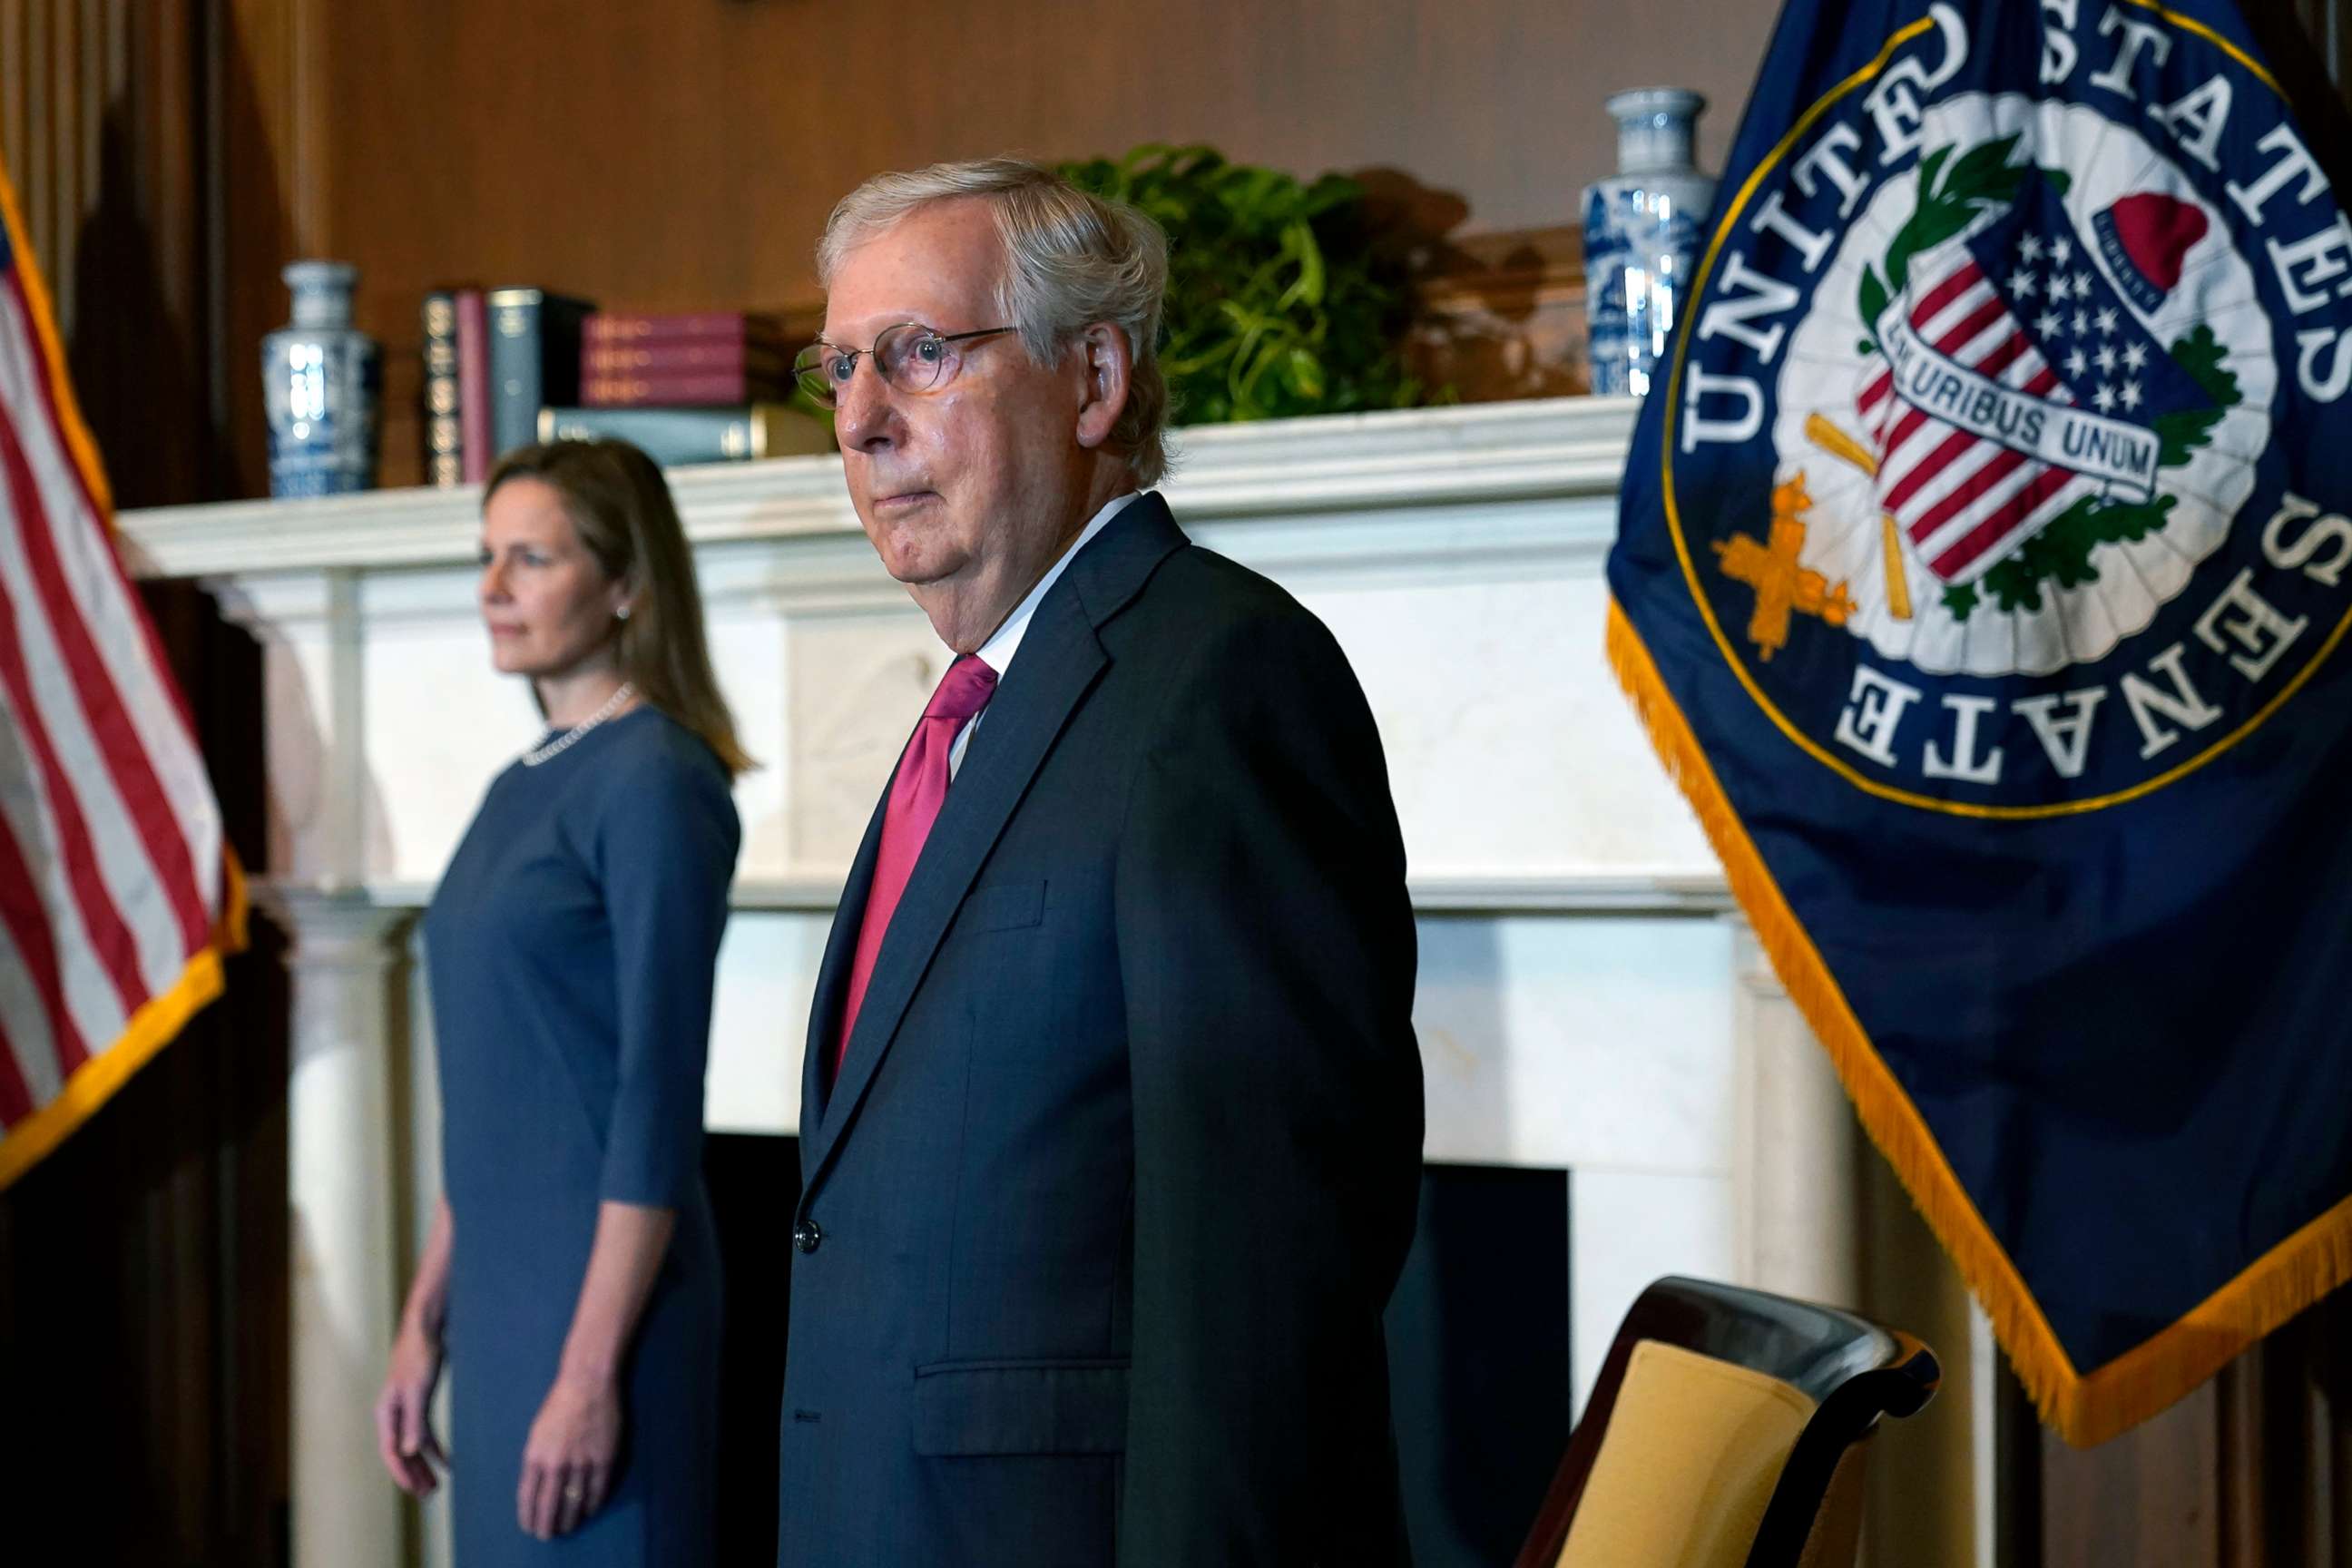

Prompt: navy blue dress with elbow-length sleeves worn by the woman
[426,708,740,1568]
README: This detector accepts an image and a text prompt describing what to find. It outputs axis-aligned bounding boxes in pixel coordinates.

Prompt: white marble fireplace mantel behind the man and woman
[122,397,1853,1568]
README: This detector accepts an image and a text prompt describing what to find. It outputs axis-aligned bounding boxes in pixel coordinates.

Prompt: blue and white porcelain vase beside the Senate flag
[1585,87,1715,395]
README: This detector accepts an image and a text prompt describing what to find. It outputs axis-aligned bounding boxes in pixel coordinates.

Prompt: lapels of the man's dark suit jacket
[799,494,1185,1187]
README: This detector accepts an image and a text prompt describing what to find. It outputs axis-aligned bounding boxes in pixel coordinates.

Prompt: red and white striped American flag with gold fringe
[0,174,245,1187]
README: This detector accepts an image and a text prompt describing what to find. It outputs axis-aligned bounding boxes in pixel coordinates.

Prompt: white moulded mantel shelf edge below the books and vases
[120,397,1640,578]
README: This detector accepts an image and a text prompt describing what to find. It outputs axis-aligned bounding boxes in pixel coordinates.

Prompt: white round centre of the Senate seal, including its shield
[1759,94,2281,686]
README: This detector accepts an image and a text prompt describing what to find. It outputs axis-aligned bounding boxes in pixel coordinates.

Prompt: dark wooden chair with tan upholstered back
[1514,1277,1943,1568]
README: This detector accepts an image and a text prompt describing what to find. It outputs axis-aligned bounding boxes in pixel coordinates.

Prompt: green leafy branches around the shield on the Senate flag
[1856,132,2244,621]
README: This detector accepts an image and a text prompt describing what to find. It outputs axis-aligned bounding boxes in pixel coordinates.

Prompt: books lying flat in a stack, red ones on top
[539,310,833,463]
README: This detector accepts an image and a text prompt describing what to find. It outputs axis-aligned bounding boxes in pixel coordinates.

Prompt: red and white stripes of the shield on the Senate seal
[1856,247,2095,583]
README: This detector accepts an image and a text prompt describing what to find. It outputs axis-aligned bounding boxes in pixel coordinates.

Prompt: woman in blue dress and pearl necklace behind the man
[377,442,750,1568]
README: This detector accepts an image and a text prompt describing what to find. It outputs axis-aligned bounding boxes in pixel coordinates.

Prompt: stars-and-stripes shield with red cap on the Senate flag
[1856,176,2206,583]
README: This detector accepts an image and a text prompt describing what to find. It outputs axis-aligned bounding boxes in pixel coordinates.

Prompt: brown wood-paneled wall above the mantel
[228,0,1773,485]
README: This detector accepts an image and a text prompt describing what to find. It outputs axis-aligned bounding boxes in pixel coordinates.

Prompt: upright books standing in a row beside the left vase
[424,289,595,485]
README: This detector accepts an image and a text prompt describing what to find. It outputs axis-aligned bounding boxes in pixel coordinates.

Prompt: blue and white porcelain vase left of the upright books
[261,261,383,496]
